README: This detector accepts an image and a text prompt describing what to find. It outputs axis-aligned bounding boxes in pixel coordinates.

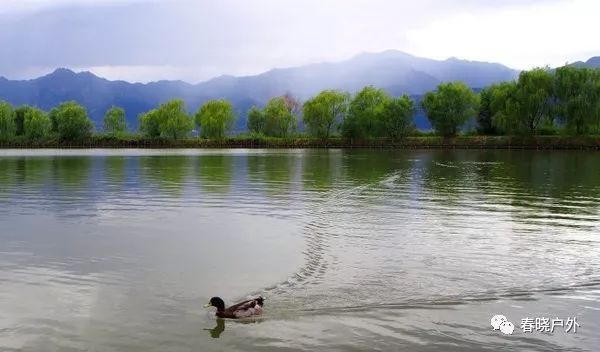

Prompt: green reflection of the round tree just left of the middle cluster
[197,154,235,193]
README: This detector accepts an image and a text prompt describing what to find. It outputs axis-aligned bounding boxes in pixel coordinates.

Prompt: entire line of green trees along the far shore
[0,66,600,143]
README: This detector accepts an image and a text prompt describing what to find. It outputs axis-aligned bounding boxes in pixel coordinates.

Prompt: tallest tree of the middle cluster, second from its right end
[342,86,391,138]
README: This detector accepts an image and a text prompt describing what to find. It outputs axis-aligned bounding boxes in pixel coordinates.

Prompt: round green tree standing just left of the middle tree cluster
[196,99,235,139]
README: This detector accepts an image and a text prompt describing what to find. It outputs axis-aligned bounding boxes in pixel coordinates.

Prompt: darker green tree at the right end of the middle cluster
[379,95,416,140]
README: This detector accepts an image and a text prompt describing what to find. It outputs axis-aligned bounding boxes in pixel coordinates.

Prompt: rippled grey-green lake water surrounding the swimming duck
[0,150,600,351]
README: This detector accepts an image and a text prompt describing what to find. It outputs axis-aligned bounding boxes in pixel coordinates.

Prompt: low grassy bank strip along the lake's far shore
[0,136,600,150]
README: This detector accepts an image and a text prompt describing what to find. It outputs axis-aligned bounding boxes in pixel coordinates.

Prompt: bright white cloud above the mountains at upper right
[407,0,600,69]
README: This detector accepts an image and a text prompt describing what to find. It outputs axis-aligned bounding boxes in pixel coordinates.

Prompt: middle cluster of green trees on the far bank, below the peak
[248,86,415,139]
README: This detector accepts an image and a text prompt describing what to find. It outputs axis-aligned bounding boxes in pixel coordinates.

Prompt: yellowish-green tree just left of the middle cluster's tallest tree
[302,90,350,139]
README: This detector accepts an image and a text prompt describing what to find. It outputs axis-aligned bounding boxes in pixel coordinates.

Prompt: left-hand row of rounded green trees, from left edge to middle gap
[0,100,235,142]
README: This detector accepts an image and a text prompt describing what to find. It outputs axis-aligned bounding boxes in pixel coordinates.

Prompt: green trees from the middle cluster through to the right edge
[248,66,600,139]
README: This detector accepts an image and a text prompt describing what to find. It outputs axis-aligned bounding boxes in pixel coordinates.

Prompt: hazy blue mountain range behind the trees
[0,51,524,130]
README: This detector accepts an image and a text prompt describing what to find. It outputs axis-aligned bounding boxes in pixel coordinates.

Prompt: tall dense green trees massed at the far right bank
[477,66,600,135]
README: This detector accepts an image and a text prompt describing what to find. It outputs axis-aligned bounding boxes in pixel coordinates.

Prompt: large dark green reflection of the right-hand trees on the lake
[421,150,600,220]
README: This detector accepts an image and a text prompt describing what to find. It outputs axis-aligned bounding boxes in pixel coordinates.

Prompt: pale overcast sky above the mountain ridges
[0,0,600,82]
